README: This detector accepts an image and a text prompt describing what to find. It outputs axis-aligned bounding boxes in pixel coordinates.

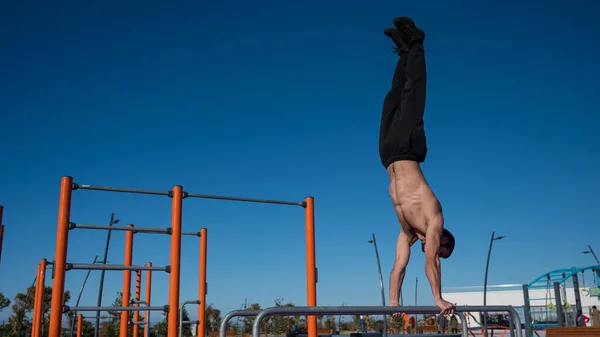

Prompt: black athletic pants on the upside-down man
[379,43,427,169]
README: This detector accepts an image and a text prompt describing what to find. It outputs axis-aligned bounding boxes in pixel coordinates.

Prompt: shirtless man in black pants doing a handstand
[379,17,454,315]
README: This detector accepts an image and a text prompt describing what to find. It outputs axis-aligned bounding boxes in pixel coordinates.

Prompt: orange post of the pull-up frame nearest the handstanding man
[304,197,317,337]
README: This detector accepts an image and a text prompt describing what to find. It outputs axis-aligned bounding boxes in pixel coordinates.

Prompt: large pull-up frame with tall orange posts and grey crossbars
[48,176,317,337]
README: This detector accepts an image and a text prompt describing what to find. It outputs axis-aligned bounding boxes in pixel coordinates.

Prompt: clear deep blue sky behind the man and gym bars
[0,0,600,318]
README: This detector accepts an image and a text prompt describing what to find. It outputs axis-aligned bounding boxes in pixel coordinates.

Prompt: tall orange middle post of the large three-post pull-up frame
[166,185,183,337]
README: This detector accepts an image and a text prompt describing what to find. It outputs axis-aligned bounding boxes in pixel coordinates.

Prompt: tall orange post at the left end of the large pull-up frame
[48,177,73,337]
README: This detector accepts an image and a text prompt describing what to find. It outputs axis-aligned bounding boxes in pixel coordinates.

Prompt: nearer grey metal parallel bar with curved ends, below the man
[252,306,522,337]
